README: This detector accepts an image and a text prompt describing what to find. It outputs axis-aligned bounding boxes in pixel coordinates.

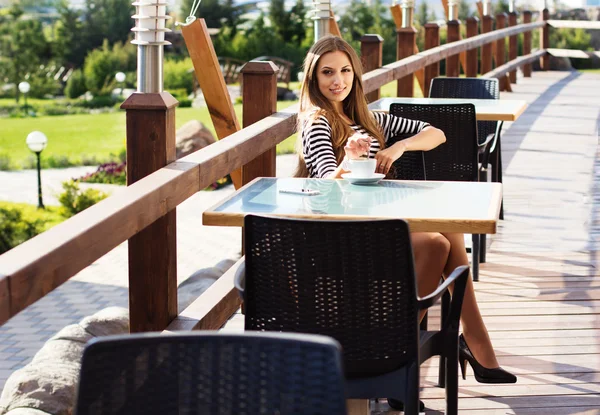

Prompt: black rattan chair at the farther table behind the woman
[429,78,504,223]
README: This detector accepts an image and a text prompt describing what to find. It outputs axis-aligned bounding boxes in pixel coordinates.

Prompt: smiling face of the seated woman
[317,50,354,108]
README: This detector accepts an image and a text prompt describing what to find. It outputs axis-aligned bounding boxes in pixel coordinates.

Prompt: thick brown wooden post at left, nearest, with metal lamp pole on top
[121,92,178,333]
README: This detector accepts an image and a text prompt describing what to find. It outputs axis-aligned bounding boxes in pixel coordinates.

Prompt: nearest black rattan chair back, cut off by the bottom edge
[75,332,346,415]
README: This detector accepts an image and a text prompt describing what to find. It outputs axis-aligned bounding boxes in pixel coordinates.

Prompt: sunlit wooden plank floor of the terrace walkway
[227,72,600,415]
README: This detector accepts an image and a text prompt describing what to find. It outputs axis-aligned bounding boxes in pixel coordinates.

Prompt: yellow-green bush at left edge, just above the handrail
[0,202,63,254]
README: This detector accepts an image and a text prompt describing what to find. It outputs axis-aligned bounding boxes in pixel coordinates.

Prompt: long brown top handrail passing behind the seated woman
[0,18,546,324]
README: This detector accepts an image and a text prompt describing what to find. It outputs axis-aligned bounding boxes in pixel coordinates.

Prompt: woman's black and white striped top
[301,111,429,178]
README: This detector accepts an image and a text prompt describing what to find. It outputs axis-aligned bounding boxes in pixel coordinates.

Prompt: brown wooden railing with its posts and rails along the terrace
[0,11,548,331]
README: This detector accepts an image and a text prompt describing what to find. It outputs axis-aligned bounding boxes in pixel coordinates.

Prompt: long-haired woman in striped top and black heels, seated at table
[296,36,517,390]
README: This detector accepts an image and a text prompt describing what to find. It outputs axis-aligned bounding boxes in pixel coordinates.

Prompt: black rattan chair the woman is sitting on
[388,104,486,281]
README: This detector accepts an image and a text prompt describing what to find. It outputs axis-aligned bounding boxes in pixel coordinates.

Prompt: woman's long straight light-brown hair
[295,35,385,177]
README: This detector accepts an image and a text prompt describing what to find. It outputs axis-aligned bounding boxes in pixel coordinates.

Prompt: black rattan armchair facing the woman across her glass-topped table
[236,215,468,414]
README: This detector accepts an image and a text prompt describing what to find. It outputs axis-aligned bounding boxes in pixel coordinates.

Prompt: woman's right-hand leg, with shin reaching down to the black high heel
[443,233,498,369]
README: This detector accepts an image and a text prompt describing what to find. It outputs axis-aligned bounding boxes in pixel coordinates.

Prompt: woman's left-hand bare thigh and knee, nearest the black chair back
[410,232,450,321]
